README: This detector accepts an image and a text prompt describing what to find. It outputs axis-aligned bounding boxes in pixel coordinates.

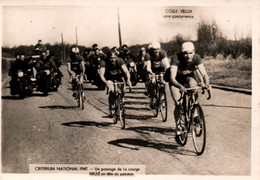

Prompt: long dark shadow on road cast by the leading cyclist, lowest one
[108,138,196,156]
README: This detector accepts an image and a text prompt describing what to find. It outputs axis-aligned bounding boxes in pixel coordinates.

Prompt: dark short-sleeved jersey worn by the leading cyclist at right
[171,53,202,75]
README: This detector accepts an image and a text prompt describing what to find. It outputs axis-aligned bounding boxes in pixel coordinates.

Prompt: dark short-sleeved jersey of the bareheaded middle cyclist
[100,58,125,81]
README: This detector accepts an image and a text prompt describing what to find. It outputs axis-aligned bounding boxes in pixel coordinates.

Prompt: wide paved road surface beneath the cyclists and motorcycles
[2,67,251,175]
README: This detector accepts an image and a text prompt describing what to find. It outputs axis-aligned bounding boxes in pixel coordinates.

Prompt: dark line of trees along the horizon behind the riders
[2,20,252,63]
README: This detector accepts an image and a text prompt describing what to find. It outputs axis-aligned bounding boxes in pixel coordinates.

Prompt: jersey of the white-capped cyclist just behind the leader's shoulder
[145,50,167,73]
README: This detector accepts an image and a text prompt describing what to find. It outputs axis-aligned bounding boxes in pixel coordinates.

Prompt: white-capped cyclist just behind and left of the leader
[145,42,170,109]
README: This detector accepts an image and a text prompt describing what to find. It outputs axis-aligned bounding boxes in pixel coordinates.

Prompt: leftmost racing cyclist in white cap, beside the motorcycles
[67,47,85,97]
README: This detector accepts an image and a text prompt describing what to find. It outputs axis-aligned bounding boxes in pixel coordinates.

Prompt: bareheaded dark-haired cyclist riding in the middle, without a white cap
[99,50,132,116]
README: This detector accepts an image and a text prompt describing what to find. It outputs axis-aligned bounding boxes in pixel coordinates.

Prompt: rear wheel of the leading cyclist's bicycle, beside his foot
[175,107,188,146]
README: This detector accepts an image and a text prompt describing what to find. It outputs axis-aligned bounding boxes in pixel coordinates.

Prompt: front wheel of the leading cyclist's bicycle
[191,104,206,155]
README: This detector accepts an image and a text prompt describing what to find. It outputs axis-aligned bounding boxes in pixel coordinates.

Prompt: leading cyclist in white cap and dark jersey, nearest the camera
[169,42,209,134]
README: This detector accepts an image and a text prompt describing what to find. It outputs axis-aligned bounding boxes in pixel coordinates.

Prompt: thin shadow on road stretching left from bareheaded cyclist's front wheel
[61,121,113,128]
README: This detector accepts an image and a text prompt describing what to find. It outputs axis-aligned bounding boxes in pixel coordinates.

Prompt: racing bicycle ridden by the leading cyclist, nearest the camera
[175,87,211,155]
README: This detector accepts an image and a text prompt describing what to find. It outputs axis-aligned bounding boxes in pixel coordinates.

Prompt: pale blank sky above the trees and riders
[2,5,252,47]
